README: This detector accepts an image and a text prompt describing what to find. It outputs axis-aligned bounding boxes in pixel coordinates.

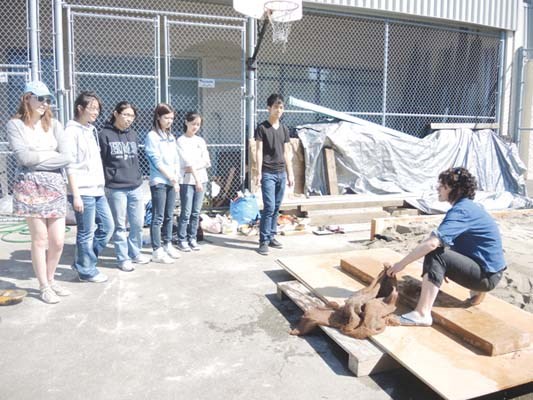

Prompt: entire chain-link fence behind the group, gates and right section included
[0,0,508,205]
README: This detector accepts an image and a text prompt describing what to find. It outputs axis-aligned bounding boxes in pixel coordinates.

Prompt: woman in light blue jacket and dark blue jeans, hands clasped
[144,103,180,264]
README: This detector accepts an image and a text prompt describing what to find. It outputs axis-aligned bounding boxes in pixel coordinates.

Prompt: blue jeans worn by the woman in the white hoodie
[68,196,115,279]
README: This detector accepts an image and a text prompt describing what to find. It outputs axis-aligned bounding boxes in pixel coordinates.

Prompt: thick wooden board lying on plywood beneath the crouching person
[341,249,533,356]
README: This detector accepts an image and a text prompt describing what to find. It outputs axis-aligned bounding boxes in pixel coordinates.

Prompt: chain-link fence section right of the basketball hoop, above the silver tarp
[258,10,502,137]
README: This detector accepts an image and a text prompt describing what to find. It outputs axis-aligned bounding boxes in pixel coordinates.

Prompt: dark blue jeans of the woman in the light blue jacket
[150,183,176,250]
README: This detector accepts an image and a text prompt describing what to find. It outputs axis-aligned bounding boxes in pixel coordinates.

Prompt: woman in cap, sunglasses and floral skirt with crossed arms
[6,81,70,304]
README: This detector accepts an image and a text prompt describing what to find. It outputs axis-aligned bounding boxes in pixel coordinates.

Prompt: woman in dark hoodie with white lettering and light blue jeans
[98,101,150,272]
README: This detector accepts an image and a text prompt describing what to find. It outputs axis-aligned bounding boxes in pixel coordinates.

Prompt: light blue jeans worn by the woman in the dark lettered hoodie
[106,186,144,264]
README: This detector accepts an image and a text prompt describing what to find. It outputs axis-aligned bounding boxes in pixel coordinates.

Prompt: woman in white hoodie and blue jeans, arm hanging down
[65,92,115,283]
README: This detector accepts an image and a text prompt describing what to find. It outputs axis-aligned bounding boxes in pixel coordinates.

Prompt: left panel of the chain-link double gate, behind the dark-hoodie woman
[66,7,161,141]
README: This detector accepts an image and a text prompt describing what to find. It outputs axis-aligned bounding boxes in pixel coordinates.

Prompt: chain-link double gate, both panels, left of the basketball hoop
[66,6,245,206]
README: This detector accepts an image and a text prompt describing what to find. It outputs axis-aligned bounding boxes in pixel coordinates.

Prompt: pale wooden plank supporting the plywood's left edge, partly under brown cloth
[277,281,399,376]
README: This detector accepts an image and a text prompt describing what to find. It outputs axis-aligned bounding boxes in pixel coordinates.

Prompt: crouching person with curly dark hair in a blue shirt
[387,168,506,326]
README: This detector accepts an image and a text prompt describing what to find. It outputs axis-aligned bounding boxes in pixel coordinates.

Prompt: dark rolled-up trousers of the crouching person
[422,247,505,292]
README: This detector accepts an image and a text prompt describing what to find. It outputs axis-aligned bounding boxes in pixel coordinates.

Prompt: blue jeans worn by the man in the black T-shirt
[259,171,287,243]
